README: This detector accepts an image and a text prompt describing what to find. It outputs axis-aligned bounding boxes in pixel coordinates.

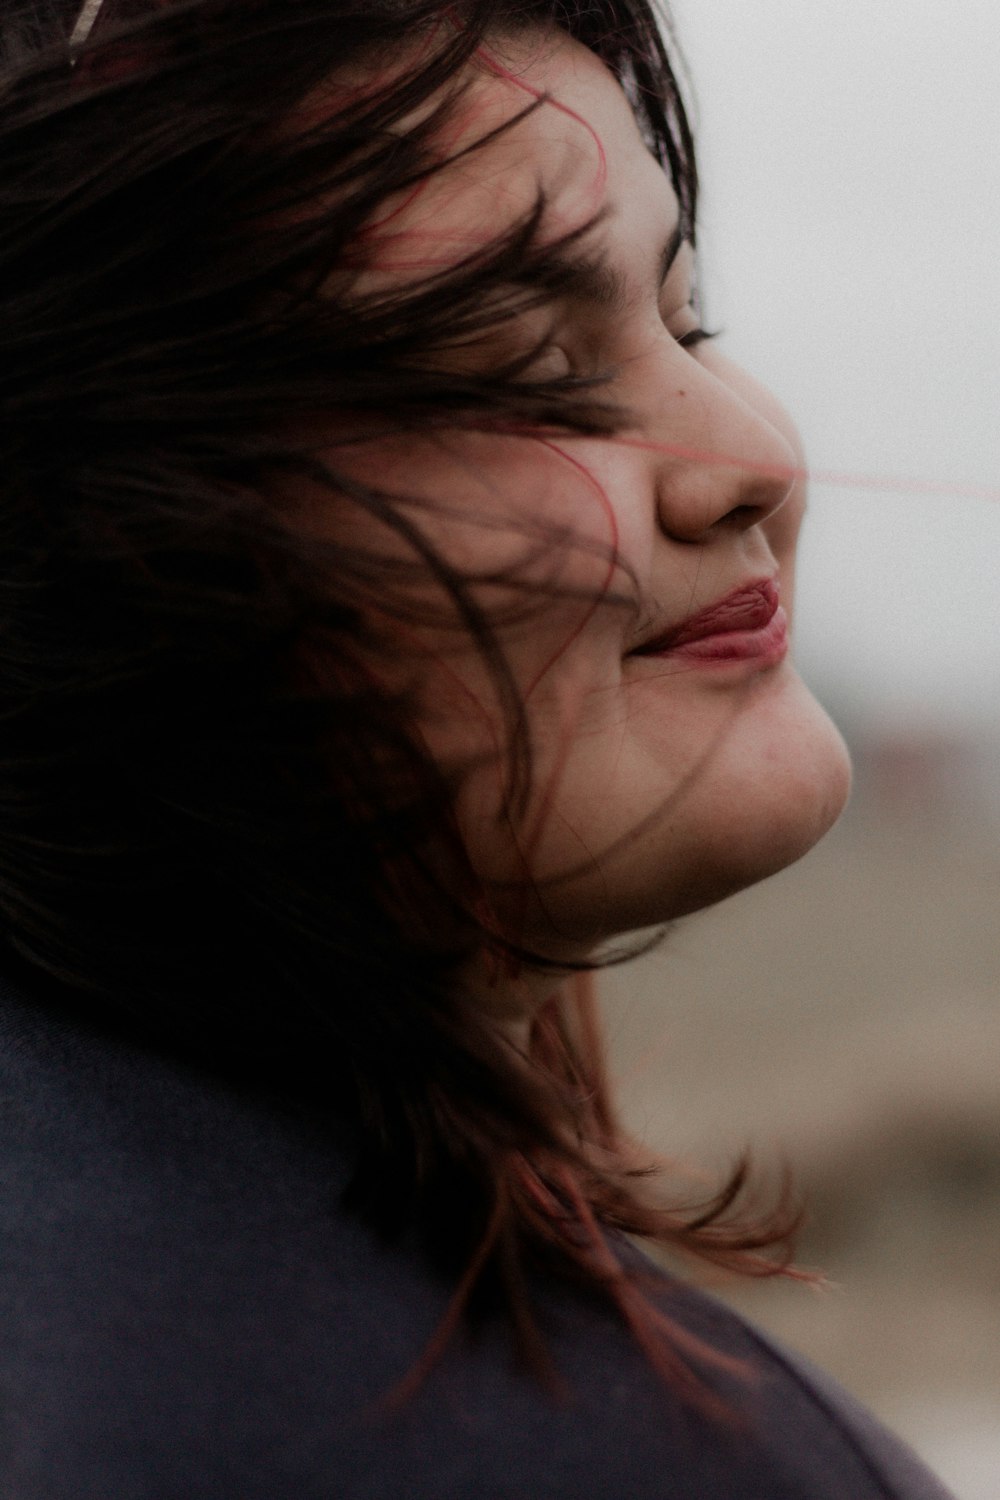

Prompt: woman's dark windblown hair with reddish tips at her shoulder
[0,0,789,1404]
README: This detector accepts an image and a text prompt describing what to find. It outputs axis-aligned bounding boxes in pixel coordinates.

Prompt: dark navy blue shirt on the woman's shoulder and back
[0,987,946,1500]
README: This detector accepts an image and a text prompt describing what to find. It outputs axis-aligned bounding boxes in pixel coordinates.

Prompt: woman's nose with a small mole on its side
[649,345,802,542]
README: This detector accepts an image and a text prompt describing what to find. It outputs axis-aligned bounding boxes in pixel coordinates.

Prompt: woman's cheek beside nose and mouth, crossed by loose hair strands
[327,432,634,699]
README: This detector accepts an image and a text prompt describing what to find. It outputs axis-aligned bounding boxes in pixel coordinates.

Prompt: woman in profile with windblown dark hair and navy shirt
[0,0,940,1500]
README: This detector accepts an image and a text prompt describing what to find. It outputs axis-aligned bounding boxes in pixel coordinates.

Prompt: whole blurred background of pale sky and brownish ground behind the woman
[604,0,1000,1500]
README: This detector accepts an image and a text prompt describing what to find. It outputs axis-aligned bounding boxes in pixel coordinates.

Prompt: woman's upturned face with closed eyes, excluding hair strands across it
[325,32,849,957]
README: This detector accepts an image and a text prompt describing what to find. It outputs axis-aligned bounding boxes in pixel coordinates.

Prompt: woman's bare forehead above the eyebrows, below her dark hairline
[353,29,678,281]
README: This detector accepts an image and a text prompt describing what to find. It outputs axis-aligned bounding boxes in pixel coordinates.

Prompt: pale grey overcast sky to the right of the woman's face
[673,0,1000,747]
